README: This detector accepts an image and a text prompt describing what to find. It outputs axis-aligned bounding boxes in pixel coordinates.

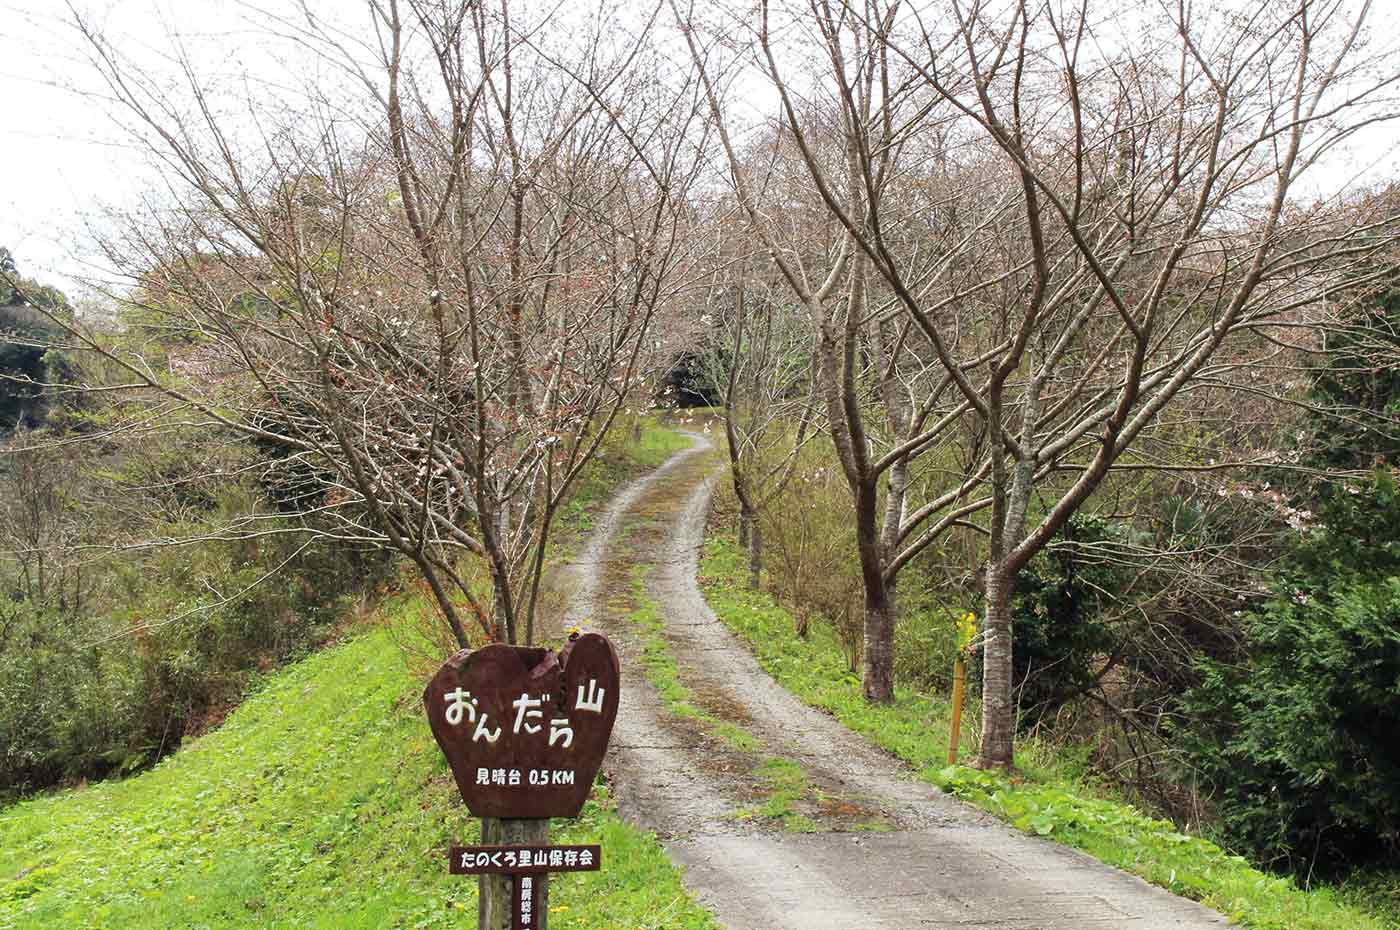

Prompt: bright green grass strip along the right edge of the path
[700,538,1400,930]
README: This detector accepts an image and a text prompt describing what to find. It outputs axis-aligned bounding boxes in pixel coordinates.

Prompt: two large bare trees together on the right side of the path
[672,0,1396,766]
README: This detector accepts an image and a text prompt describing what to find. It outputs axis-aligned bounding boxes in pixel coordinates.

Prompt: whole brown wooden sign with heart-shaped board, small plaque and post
[423,633,619,930]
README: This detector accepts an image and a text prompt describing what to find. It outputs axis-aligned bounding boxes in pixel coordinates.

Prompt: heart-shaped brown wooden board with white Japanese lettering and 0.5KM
[423,633,619,818]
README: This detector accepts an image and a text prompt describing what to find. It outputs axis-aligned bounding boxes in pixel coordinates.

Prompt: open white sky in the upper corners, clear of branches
[0,0,1400,293]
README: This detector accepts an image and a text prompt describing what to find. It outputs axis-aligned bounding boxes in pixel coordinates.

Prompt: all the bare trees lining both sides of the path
[10,0,1397,766]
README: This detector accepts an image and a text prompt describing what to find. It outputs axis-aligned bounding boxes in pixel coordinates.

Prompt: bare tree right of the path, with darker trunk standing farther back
[672,4,994,702]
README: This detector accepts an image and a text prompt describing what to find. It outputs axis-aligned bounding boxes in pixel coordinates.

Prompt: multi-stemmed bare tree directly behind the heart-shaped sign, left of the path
[31,0,703,646]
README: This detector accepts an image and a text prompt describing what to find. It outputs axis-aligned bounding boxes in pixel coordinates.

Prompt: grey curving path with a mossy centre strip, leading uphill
[551,434,1226,930]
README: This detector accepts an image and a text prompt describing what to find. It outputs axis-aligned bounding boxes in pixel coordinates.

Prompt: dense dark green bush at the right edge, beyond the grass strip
[1182,473,1400,874]
